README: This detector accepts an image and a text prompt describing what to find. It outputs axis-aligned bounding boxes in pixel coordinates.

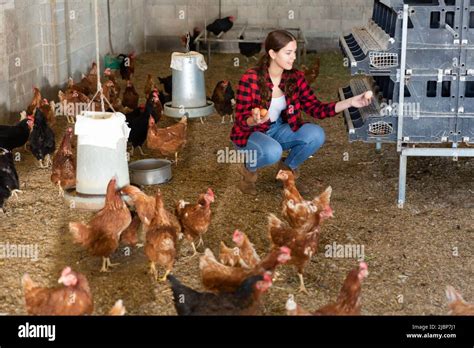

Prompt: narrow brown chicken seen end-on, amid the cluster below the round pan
[145,190,180,281]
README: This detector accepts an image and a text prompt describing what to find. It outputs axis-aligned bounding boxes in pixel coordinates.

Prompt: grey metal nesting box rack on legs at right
[339,0,474,208]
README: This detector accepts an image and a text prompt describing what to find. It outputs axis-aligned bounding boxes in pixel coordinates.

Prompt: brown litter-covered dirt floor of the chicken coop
[0,53,474,315]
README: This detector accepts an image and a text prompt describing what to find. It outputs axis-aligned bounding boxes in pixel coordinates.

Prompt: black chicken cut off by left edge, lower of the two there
[0,148,21,212]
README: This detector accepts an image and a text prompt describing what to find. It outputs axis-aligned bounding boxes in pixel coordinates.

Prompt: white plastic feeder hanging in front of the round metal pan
[66,111,130,209]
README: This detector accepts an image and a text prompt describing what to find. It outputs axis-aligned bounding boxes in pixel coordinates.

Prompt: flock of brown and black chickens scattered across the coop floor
[0,36,474,315]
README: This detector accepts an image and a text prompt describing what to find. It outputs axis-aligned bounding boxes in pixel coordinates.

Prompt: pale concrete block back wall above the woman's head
[145,0,373,52]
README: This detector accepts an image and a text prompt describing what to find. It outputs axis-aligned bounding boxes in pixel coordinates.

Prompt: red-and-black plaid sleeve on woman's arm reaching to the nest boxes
[298,72,336,119]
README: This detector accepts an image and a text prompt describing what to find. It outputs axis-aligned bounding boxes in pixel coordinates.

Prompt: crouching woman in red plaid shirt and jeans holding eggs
[230,30,371,195]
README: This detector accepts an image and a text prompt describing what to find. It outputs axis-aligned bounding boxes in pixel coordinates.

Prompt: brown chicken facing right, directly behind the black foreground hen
[199,247,291,292]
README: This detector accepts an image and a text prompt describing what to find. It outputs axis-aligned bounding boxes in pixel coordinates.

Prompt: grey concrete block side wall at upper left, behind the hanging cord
[0,0,145,124]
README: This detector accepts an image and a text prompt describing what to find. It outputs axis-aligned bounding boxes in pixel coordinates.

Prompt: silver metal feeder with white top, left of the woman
[163,51,215,118]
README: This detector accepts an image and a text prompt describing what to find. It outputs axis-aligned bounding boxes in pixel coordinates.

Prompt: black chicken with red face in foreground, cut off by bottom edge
[168,274,271,315]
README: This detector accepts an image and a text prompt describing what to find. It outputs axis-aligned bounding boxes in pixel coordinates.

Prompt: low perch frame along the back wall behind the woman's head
[194,24,308,65]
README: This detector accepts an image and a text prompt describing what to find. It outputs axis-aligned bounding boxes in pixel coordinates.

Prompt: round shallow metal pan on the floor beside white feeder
[129,158,172,185]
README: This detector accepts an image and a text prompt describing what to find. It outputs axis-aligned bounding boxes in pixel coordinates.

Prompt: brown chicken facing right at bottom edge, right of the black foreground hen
[286,262,369,315]
